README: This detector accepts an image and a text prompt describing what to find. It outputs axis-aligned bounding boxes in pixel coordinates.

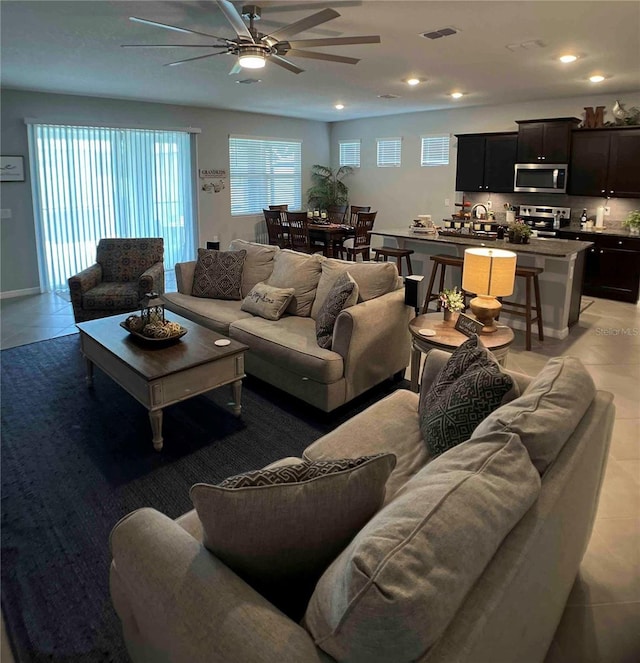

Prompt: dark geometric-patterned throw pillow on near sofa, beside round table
[420,337,514,457]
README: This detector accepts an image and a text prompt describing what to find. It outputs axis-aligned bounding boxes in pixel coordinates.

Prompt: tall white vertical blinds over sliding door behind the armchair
[29,124,196,290]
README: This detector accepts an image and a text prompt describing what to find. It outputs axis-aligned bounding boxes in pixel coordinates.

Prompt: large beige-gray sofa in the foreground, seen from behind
[111,350,614,663]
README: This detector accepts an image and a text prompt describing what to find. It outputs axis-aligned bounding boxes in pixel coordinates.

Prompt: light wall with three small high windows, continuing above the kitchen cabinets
[331,92,640,230]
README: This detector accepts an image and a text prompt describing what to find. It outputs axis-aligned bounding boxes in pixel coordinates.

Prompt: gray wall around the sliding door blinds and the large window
[0,90,330,293]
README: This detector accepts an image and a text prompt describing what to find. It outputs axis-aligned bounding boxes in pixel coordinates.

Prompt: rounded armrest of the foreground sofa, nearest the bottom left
[110,509,323,663]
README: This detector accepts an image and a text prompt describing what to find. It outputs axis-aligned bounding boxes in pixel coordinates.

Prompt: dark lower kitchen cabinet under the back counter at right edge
[558,230,640,303]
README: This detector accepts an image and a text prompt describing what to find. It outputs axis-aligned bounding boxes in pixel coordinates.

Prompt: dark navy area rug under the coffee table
[0,334,407,663]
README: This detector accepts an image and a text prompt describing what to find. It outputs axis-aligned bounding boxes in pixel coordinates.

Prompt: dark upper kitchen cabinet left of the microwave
[456,132,518,193]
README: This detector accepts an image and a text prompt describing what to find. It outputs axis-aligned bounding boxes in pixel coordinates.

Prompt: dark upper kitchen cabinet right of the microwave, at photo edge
[568,128,640,198]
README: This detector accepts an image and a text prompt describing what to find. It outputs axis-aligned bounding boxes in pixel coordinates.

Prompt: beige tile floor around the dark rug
[0,292,640,663]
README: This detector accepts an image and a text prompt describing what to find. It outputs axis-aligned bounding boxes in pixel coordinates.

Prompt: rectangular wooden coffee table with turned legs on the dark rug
[76,313,249,451]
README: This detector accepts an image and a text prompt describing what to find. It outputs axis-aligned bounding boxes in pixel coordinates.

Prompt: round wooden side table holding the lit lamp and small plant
[409,311,514,391]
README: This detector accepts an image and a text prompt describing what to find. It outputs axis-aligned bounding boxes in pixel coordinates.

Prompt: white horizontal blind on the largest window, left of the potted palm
[229,136,302,216]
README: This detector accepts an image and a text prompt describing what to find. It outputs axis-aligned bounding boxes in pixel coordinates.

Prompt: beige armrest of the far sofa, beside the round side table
[332,290,413,400]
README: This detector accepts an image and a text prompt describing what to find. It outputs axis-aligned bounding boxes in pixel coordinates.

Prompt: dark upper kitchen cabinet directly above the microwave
[517,117,580,163]
